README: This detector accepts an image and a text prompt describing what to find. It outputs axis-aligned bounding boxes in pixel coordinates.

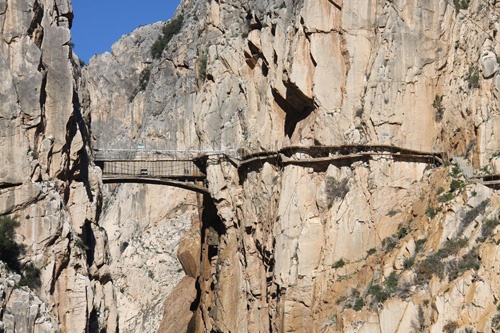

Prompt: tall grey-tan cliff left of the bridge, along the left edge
[0,0,117,332]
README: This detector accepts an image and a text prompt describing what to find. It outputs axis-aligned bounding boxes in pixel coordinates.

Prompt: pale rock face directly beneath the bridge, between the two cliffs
[96,184,200,332]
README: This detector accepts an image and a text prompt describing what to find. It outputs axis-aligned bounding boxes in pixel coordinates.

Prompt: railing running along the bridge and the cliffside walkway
[95,145,443,180]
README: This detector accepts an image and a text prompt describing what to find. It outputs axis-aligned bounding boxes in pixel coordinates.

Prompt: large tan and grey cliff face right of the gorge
[84,0,500,332]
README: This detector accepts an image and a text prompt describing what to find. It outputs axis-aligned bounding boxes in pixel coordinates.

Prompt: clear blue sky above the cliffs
[71,0,180,63]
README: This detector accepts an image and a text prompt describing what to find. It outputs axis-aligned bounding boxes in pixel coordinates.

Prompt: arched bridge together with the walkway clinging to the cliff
[94,145,458,193]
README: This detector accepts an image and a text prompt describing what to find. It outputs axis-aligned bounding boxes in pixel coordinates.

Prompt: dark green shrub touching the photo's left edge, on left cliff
[0,216,24,271]
